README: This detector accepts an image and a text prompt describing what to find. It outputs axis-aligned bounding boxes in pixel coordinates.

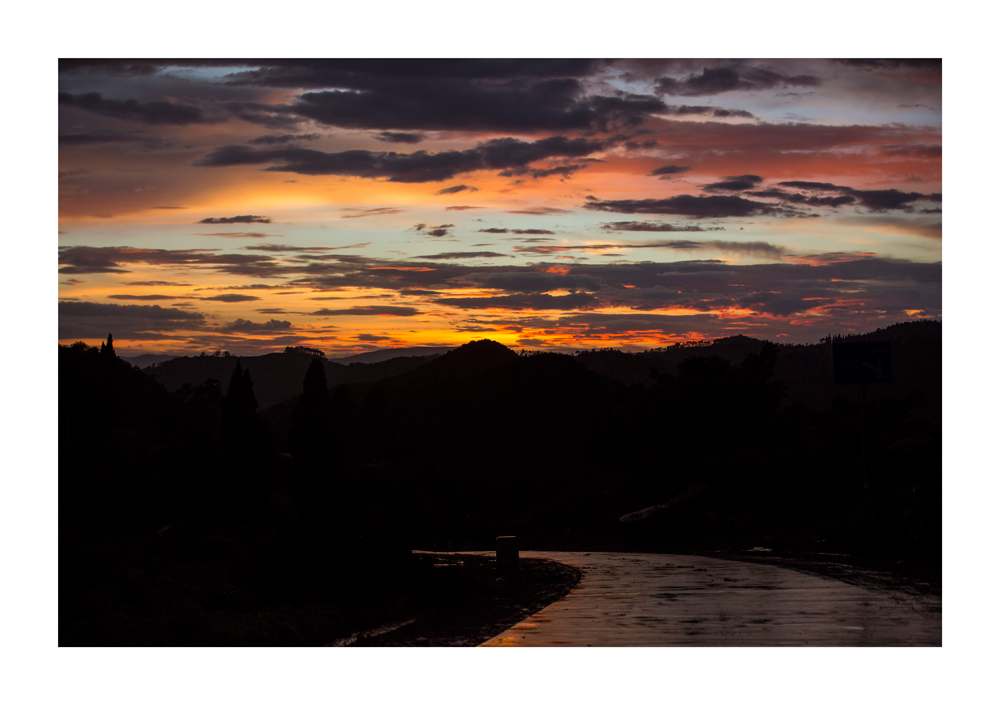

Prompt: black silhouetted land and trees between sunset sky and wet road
[59,323,941,645]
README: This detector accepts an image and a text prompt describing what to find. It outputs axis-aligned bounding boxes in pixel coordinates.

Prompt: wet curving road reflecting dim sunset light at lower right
[481,551,941,646]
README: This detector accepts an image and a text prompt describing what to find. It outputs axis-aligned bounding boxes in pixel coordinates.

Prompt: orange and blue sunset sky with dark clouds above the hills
[58,59,942,356]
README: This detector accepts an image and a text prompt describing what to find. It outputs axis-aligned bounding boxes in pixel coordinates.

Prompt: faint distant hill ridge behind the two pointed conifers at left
[146,353,442,409]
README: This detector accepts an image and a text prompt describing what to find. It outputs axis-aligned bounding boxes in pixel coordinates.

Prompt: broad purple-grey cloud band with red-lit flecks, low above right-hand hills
[276,246,941,328]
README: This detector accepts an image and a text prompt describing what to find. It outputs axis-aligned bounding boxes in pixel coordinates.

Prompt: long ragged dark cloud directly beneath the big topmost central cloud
[195,136,604,183]
